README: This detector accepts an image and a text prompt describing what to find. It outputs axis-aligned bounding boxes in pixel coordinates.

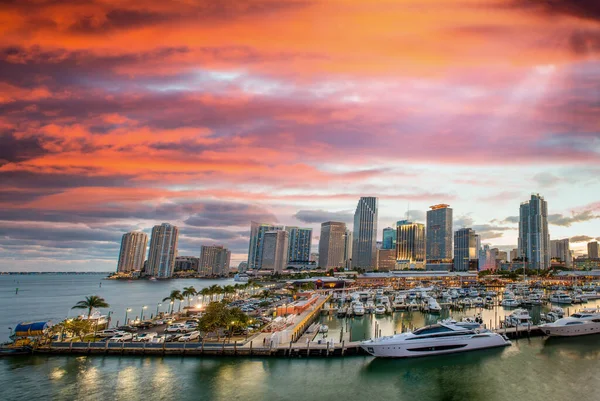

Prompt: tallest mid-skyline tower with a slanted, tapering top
[352,196,378,270]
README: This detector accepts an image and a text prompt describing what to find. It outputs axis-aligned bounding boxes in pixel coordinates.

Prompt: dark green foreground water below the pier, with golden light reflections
[0,336,600,401]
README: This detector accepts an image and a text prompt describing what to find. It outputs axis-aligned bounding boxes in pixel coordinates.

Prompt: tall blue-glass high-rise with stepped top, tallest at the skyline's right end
[519,194,550,270]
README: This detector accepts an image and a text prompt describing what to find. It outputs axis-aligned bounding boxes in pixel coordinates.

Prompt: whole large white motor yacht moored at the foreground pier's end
[361,323,510,358]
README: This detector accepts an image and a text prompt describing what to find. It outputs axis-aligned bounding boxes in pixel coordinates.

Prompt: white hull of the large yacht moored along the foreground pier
[361,335,510,358]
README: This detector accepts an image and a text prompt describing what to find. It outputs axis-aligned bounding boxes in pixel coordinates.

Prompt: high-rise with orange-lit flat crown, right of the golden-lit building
[426,204,452,264]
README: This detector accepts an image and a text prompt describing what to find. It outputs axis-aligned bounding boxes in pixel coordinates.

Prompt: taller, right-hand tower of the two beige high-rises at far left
[148,223,179,278]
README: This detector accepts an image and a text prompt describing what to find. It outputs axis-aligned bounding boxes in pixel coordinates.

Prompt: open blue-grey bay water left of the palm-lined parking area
[0,274,235,342]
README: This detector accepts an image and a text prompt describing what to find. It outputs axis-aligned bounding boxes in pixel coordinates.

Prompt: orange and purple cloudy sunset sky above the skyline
[0,0,600,271]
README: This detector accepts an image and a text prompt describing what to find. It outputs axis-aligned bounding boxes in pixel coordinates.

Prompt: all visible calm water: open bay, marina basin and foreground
[0,275,600,401]
